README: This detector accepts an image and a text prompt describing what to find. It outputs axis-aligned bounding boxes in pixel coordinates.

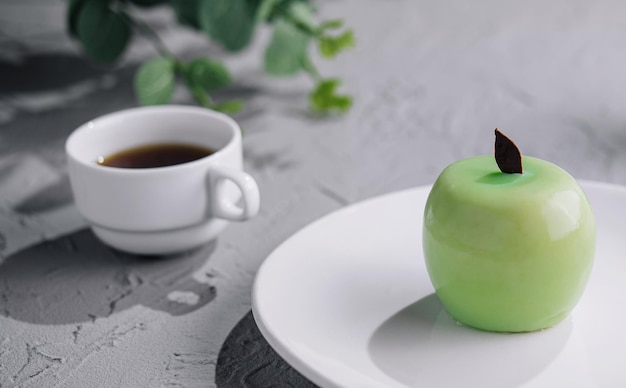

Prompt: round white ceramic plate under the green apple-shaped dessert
[252,182,626,388]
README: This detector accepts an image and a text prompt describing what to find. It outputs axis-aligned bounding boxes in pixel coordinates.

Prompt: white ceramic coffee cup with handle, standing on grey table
[65,105,260,254]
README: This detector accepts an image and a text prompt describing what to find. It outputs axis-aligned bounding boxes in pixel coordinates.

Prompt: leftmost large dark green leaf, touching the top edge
[76,0,131,63]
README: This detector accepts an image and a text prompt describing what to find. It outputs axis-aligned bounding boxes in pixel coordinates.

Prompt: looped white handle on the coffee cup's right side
[208,166,261,221]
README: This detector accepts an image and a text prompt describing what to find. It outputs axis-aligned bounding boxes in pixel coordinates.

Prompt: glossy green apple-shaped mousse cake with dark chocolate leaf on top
[423,129,596,332]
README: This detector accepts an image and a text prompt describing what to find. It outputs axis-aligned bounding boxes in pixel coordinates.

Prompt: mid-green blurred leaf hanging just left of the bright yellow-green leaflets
[264,19,310,76]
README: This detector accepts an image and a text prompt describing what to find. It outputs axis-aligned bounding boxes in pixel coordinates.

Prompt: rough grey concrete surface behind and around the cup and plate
[0,0,626,387]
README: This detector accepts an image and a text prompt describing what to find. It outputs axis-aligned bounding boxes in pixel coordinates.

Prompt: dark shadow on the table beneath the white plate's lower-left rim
[215,312,316,388]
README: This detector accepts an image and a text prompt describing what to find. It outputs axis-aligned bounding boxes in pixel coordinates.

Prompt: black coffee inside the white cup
[98,143,215,168]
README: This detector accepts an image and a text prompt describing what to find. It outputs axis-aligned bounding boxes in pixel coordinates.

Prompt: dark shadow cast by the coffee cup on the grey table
[0,230,216,324]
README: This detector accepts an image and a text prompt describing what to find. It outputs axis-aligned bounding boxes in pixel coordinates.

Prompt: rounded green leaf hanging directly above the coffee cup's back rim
[135,57,175,105]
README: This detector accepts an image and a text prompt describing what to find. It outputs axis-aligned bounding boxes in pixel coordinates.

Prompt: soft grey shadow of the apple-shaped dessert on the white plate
[368,294,572,388]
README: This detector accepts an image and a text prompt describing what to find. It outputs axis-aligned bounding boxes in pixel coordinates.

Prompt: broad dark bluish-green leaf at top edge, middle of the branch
[200,0,259,51]
